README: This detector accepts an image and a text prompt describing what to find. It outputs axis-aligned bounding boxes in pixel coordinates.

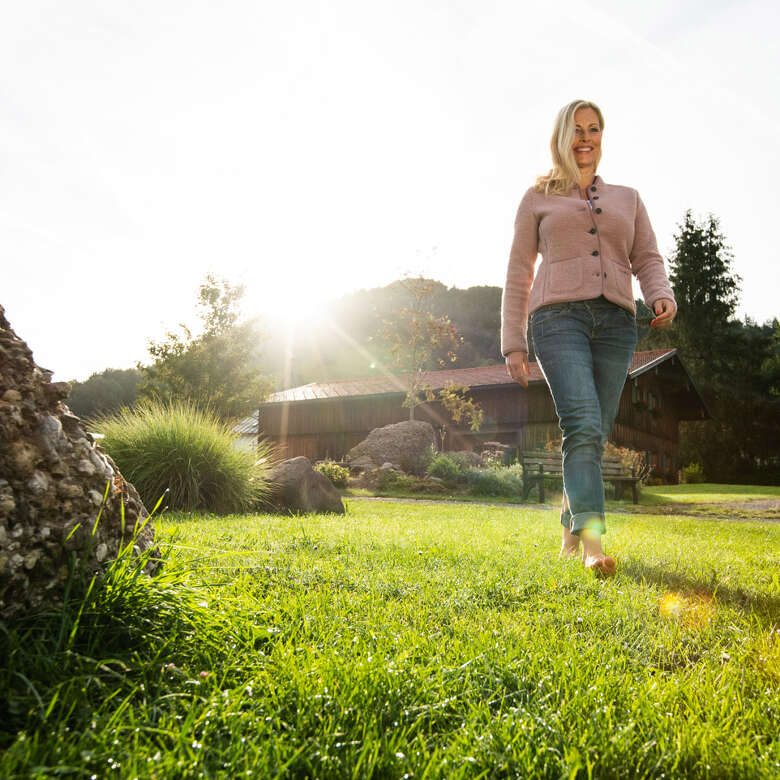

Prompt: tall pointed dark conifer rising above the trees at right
[669,209,742,380]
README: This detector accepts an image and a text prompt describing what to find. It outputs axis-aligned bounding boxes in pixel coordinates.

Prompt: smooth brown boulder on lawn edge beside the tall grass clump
[269,456,344,515]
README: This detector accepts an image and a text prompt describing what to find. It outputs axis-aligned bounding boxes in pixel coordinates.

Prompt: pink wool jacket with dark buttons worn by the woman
[501,175,674,355]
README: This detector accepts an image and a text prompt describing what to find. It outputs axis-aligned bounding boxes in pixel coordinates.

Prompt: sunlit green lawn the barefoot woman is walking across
[0,502,780,780]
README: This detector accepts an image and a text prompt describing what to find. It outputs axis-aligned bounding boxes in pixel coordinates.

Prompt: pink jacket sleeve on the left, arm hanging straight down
[501,187,539,356]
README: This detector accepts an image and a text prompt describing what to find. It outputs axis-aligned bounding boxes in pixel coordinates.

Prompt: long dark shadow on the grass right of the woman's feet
[619,558,780,625]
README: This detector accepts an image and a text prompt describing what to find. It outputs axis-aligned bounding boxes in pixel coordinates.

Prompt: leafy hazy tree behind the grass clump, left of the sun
[139,274,270,419]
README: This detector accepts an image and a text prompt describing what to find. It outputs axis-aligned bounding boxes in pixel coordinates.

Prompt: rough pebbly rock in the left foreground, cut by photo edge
[0,306,155,618]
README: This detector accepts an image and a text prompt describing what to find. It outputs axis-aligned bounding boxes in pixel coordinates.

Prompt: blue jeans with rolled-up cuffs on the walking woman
[531,296,637,534]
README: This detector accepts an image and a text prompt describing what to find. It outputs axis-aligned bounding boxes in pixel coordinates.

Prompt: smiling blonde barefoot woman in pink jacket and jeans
[501,100,677,576]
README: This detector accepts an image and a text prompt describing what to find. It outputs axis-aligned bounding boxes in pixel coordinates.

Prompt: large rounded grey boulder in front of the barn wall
[347,420,436,474]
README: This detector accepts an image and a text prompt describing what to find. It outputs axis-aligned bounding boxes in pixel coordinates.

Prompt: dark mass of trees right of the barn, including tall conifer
[664,210,780,482]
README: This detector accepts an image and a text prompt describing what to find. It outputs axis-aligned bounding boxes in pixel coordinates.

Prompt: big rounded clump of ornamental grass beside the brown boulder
[94,401,273,514]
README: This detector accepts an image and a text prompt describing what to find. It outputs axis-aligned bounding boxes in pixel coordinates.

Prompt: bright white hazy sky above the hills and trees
[0,0,780,380]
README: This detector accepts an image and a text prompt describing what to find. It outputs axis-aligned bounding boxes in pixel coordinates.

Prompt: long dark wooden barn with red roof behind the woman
[249,349,709,481]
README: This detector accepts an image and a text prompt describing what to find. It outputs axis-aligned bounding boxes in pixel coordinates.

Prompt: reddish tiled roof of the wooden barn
[260,349,677,406]
